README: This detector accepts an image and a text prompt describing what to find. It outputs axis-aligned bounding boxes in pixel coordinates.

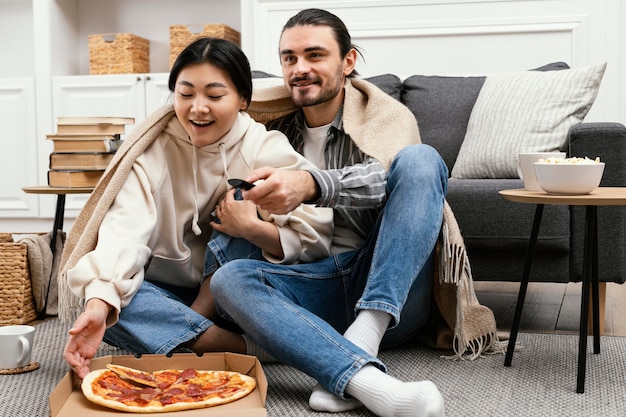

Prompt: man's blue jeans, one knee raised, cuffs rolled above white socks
[211,145,448,396]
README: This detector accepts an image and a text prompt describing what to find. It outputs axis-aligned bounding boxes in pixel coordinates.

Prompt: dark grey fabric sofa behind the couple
[255,63,626,283]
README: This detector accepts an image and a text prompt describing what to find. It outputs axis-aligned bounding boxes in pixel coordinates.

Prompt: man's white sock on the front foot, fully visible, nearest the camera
[346,365,445,417]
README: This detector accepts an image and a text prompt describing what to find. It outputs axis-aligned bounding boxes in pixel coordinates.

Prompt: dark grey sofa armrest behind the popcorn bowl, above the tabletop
[566,122,626,187]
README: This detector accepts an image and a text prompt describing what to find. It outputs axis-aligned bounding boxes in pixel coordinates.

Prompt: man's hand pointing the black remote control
[242,167,319,214]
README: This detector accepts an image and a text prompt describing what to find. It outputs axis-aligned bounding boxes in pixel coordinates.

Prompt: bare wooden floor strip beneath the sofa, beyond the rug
[474,281,626,336]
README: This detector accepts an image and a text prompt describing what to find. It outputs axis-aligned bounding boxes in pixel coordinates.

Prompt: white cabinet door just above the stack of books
[52,74,146,134]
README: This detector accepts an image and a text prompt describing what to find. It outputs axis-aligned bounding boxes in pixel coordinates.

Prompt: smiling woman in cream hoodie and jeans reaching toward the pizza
[60,38,332,377]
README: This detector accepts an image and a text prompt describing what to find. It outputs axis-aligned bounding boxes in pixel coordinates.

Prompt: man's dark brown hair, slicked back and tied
[281,9,363,78]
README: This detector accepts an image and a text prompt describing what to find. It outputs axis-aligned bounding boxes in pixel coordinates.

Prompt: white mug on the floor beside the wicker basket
[0,325,35,369]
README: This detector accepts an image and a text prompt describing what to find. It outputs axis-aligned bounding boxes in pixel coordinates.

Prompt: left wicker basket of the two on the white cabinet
[89,33,150,75]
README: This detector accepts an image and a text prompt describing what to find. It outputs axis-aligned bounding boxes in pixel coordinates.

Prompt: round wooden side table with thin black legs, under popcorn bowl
[500,187,626,393]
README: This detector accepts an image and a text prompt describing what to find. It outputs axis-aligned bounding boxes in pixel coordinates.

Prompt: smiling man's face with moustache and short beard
[279,25,353,107]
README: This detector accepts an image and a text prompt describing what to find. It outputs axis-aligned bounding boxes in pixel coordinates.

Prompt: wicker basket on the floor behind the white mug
[0,233,37,326]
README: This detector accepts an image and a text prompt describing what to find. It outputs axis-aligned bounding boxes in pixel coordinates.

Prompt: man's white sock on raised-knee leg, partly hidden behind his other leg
[309,310,391,413]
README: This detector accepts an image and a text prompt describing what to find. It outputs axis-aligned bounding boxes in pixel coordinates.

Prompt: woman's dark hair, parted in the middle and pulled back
[167,37,252,104]
